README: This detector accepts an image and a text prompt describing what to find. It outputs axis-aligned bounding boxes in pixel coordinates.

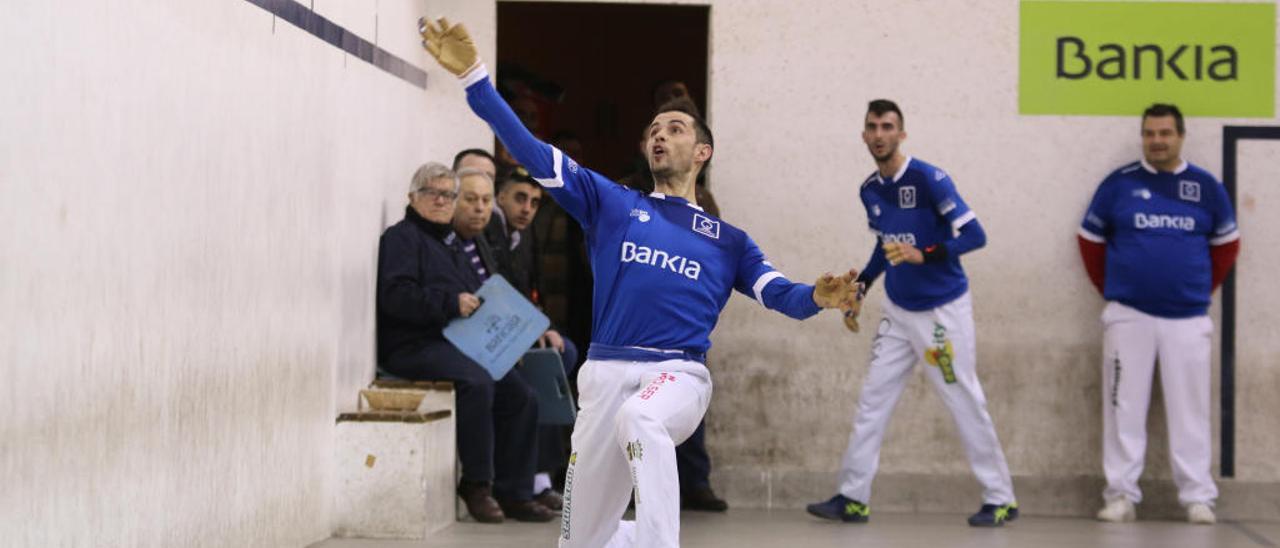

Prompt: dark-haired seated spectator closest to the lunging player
[485,168,577,510]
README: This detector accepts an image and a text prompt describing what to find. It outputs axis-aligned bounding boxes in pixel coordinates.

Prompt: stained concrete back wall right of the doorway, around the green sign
[708,1,1280,513]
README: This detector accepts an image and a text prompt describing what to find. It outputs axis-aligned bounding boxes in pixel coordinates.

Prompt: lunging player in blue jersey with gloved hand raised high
[421,19,852,548]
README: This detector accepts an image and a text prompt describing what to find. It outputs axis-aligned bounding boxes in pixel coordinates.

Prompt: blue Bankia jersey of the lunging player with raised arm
[467,68,819,361]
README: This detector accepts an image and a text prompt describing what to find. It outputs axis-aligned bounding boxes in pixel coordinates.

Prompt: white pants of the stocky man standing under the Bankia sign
[1102,302,1217,506]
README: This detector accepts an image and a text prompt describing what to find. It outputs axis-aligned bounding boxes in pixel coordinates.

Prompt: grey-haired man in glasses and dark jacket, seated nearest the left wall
[376,163,554,522]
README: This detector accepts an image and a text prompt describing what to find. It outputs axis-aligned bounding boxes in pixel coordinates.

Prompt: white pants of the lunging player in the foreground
[559,360,712,548]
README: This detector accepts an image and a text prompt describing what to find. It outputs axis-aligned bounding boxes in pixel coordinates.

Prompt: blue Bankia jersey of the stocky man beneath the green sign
[1079,161,1240,318]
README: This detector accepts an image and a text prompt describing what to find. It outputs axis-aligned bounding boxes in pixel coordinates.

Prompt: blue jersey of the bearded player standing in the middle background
[859,157,980,311]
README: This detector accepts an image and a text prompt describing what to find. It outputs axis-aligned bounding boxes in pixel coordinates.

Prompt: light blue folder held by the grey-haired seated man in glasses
[444,274,552,380]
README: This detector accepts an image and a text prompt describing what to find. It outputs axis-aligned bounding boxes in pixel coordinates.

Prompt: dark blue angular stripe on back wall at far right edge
[1220,125,1280,478]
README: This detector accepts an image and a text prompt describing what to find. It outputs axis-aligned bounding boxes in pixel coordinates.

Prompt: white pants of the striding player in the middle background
[840,293,1015,504]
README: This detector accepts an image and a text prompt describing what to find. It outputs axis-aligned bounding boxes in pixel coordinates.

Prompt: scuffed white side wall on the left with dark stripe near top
[0,0,494,547]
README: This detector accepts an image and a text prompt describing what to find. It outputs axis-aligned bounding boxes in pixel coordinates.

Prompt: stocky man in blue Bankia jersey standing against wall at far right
[1079,104,1240,524]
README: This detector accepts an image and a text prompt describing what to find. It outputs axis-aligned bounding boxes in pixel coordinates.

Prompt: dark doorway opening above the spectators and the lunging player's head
[498,1,710,179]
